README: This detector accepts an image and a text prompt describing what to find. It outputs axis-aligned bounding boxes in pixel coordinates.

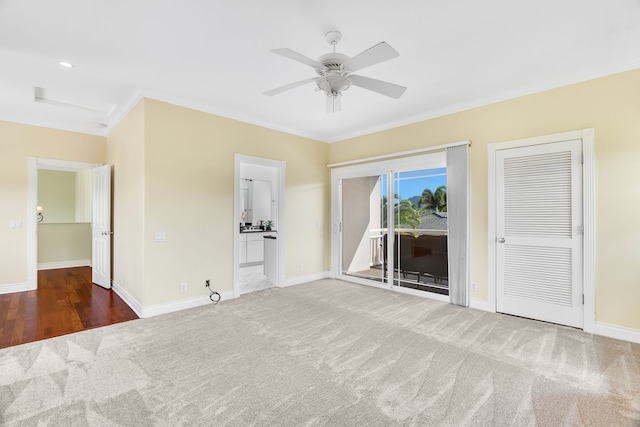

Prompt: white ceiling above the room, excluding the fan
[0,0,640,142]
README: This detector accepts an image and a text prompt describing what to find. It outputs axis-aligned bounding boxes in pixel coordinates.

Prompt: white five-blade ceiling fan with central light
[264,31,407,113]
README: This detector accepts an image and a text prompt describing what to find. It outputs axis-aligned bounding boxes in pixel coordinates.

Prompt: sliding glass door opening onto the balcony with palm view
[335,153,449,295]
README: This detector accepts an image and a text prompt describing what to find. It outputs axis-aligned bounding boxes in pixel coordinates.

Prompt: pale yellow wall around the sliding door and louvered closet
[329,70,640,329]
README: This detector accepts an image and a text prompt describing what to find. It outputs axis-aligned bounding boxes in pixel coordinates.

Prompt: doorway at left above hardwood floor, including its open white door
[25,158,112,290]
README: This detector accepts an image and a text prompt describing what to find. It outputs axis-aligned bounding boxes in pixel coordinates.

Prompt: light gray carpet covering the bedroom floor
[0,280,640,426]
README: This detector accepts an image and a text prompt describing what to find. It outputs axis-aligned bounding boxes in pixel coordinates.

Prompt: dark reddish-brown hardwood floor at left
[0,267,138,348]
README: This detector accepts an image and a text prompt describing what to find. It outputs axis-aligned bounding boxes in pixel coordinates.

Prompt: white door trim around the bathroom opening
[233,154,287,298]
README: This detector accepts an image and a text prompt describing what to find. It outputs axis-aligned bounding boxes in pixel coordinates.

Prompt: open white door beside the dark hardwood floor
[91,165,112,289]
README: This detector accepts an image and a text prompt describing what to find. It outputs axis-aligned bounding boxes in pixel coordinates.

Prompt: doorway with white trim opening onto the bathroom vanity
[233,154,286,298]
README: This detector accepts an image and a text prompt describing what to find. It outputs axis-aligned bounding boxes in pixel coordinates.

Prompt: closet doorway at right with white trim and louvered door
[488,129,595,331]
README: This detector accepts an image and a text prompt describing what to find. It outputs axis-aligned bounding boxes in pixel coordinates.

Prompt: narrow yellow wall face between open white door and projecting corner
[107,100,145,304]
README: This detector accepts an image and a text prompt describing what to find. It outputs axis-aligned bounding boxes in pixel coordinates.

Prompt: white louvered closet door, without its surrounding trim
[496,140,583,327]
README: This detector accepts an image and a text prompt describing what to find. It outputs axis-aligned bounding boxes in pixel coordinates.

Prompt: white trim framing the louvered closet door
[486,129,596,333]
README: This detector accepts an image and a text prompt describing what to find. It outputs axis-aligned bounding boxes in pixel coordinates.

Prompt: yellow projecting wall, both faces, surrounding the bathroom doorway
[109,99,330,306]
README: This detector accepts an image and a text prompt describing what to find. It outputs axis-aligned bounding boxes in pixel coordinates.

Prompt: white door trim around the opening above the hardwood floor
[25,157,100,291]
